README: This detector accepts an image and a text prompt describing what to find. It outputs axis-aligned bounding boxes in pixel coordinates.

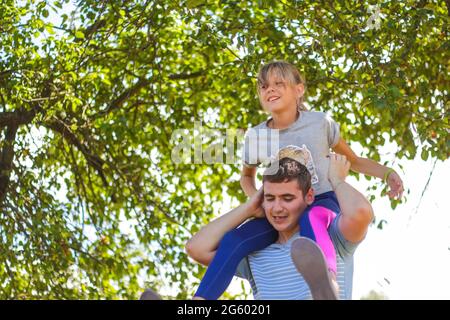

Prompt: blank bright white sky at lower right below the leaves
[229,148,450,299]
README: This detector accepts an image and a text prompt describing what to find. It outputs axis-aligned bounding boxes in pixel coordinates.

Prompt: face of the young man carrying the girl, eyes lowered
[263,180,314,233]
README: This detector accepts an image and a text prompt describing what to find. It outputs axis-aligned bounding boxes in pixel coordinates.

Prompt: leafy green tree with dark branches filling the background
[0,0,450,299]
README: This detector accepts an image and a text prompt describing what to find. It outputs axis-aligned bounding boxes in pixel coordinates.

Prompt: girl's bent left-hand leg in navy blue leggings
[195,218,278,300]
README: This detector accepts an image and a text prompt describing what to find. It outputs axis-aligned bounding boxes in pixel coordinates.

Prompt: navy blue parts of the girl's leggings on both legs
[195,191,340,300]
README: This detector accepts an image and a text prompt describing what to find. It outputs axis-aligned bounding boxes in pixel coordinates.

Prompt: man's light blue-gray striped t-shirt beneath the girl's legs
[235,215,359,300]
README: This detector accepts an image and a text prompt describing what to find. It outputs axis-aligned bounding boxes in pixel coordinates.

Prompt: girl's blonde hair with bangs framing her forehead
[258,61,307,111]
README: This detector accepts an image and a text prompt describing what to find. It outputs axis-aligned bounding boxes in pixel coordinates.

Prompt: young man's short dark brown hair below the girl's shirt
[263,157,311,196]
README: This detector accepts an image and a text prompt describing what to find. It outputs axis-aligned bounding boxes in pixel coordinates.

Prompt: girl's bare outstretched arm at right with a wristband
[333,138,403,199]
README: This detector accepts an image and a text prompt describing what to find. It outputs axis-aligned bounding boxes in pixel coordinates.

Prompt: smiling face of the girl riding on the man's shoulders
[258,72,304,113]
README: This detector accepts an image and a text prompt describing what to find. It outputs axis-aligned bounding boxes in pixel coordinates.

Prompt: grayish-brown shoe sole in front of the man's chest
[291,237,339,300]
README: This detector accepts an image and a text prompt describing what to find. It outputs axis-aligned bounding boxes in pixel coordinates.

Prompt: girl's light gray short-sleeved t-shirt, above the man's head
[243,111,340,194]
